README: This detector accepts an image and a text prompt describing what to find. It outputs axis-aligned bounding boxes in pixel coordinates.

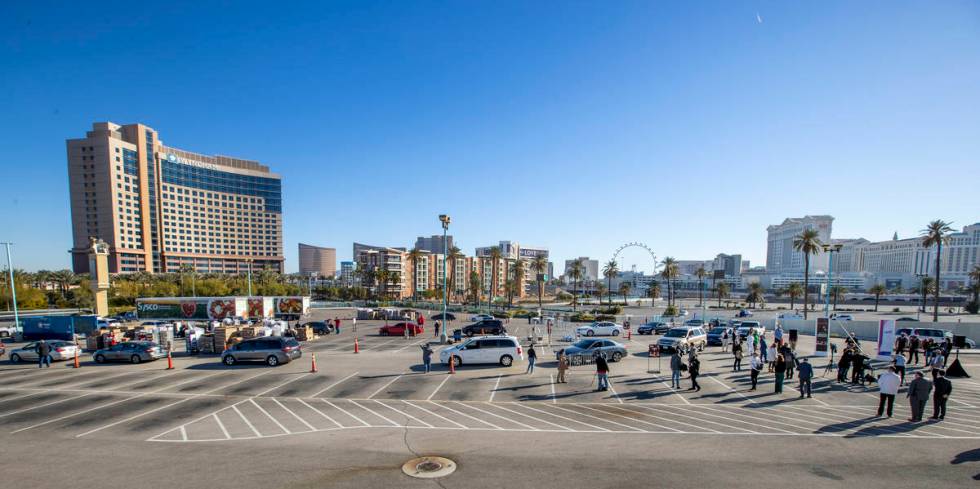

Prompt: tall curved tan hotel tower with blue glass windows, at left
[67,122,284,273]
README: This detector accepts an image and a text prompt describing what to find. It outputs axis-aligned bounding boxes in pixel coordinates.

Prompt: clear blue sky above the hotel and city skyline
[0,1,980,271]
